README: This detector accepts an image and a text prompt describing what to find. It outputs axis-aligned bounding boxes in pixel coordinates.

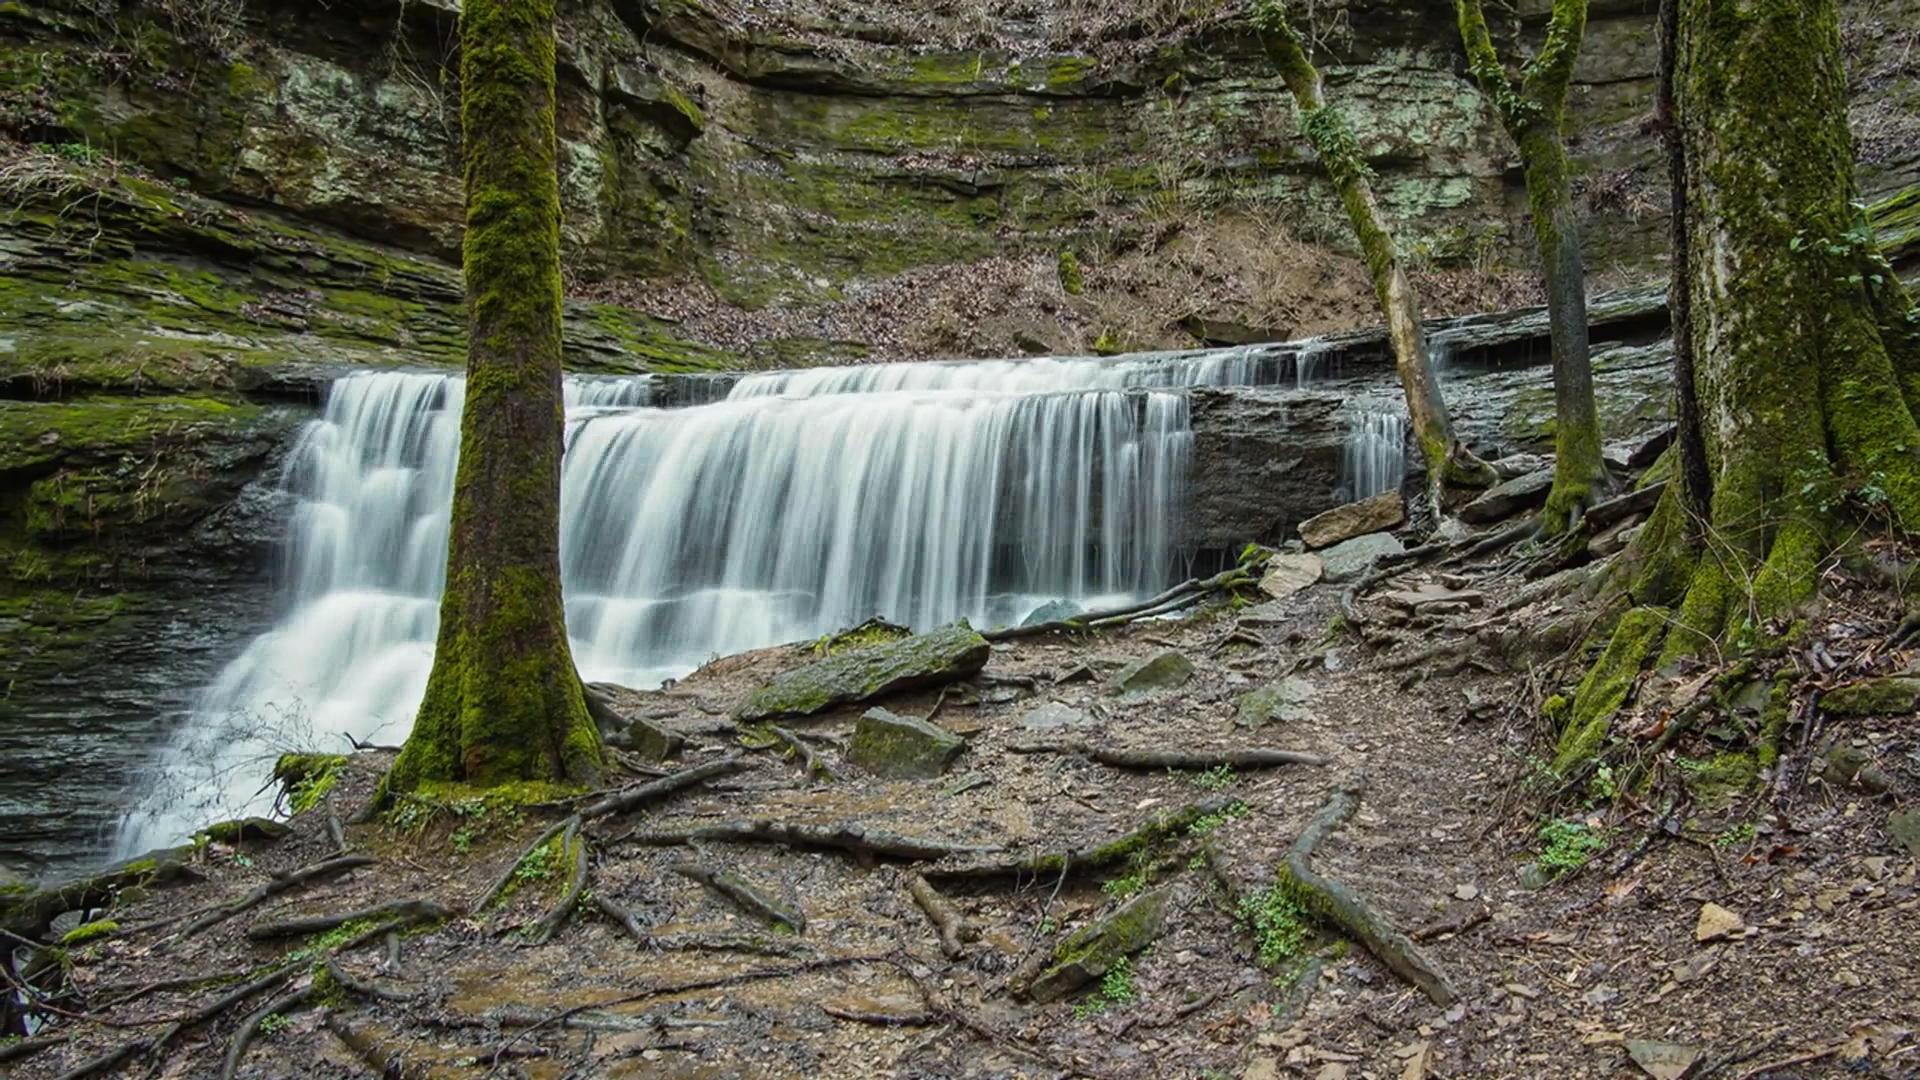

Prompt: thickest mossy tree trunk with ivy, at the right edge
[1561,0,1920,763]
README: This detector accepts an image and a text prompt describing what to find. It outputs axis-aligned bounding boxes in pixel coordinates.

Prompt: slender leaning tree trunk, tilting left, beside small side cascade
[1254,0,1494,507]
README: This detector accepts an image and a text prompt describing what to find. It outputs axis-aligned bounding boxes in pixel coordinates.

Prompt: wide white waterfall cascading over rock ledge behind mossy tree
[117,350,1275,853]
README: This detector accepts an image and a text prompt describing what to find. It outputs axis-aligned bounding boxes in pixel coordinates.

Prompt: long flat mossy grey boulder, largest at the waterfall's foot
[739,623,993,721]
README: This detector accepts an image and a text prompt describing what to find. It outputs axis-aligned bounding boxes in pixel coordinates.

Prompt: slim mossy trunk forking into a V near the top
[1453,0,1607,536]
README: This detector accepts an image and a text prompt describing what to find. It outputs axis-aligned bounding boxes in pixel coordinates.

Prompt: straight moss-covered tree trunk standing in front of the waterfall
[388,0,601,792]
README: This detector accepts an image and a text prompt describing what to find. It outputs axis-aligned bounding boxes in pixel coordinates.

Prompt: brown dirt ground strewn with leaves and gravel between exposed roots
[0,549,1920,1080]
